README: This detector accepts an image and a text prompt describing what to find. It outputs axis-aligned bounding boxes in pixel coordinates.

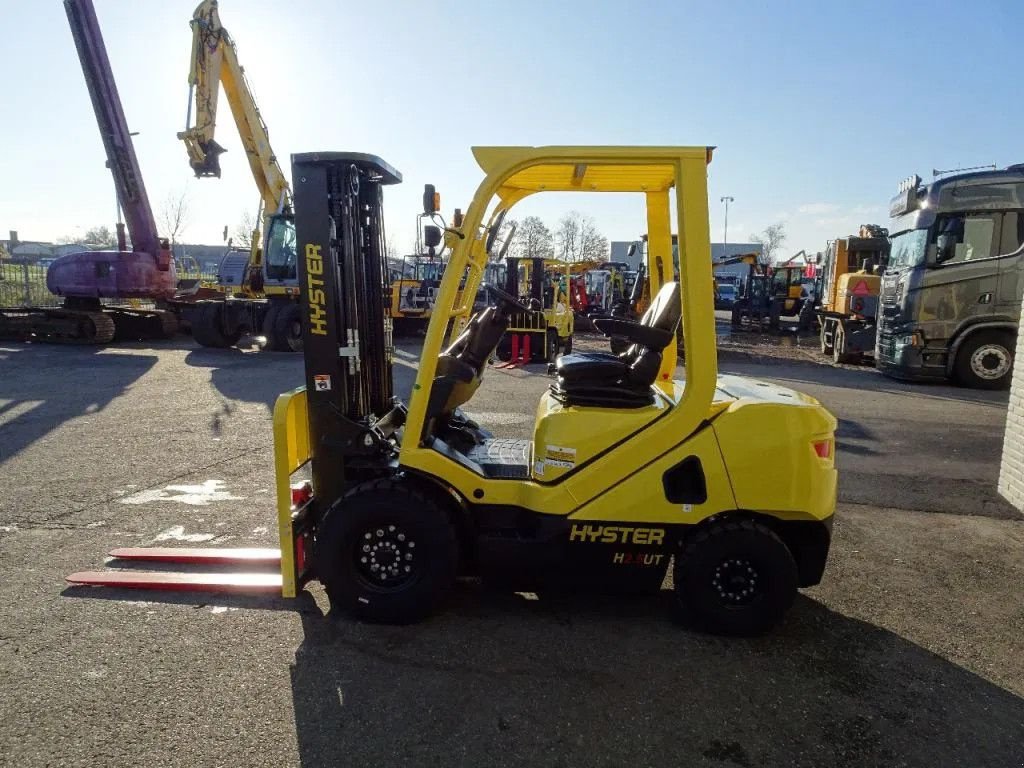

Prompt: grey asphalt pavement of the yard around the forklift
[0,341,1024,768]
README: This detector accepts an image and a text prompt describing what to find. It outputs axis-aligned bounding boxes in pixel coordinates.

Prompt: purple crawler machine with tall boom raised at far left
[0,0,178,344]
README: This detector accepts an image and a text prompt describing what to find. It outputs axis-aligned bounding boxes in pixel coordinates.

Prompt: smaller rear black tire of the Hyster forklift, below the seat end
[674,519,798,636]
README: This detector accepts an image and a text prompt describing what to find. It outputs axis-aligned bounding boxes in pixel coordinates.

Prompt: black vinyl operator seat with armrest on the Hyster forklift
[551,283,681,408]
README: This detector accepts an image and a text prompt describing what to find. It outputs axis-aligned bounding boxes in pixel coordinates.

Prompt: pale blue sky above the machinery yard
[0,0,1024,259]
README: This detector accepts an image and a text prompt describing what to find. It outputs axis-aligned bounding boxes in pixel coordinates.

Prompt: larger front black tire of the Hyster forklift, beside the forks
[314,479,459,624]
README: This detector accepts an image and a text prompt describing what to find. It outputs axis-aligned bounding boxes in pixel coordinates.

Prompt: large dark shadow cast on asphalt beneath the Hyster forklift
[292,585,1024,768]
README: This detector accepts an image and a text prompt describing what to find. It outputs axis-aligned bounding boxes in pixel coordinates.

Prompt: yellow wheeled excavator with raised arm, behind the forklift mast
[178,0,302,351]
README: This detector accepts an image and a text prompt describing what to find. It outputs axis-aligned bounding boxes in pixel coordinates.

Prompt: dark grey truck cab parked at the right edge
[876,164,1024,389]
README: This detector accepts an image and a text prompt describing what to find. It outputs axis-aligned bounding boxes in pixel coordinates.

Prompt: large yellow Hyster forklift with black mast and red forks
[69,146,837,635]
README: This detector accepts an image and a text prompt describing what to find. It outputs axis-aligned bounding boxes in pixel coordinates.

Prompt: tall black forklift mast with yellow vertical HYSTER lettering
[292,153,404,511]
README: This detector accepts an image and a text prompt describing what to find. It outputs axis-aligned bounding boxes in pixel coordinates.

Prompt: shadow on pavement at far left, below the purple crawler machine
[0,343,157,465]
